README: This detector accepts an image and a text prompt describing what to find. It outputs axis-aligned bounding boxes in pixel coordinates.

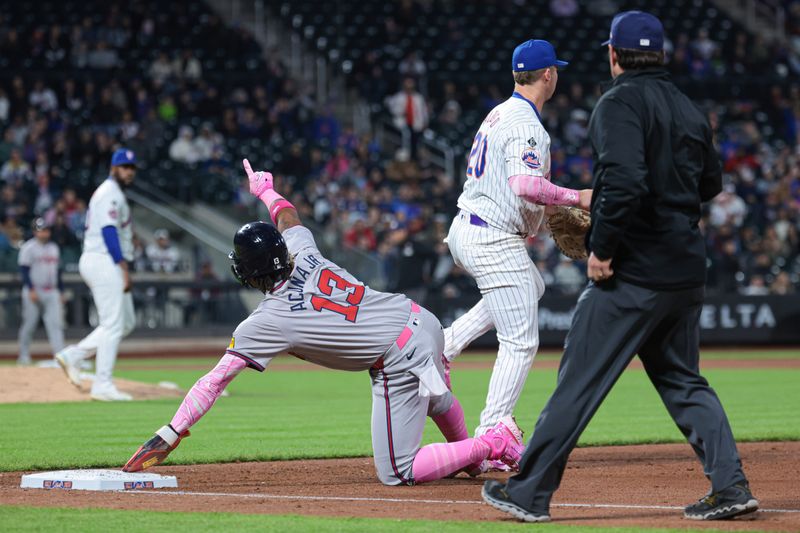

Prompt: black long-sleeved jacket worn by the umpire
[586,68,722,290]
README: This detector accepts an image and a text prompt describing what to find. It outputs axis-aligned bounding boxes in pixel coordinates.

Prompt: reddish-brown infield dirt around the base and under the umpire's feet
[0,442,800,531]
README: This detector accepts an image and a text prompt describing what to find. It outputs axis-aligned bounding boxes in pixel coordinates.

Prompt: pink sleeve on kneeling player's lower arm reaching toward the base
[170,354,247,435]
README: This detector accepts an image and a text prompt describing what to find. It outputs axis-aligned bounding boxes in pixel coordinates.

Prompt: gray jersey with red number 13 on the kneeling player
[227,226,411,371]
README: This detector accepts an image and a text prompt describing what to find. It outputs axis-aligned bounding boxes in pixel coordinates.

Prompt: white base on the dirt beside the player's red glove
[19,469,178,490]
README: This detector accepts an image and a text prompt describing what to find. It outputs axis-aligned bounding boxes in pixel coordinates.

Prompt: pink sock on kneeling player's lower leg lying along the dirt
[411,439,492,483]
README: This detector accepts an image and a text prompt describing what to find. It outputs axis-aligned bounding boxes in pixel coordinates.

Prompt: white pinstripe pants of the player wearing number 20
[444,213,544,435]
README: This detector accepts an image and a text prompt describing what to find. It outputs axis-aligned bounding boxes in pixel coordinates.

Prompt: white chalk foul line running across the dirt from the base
[119,490,800,513]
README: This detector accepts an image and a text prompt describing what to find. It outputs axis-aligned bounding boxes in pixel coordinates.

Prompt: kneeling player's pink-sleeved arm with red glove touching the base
[122,354,247,472]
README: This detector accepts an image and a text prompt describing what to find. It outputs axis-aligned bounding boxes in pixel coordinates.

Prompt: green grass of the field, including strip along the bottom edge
[0,351,800,531]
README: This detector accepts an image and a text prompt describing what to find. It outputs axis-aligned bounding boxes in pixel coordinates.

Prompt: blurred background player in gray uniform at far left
[17,218,64,365]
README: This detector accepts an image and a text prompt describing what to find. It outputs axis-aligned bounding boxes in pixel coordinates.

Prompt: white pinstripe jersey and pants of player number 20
[445,93,550,435]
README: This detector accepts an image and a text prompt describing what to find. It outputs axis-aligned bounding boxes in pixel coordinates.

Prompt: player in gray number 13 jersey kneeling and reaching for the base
[124,160,522,485]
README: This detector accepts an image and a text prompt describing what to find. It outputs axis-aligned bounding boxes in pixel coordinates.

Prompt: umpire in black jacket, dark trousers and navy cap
[483,11,758,522]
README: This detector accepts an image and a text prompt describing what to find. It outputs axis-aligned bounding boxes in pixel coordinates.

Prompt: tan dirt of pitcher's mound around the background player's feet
[0,366,183,403]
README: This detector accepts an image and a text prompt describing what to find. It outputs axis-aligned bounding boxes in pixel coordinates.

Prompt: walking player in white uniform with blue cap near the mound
[56,148,136,401]
